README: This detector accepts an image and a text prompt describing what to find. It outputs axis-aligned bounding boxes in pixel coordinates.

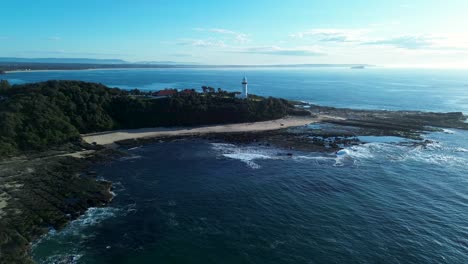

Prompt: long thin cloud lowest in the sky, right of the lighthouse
[233,46,326,56]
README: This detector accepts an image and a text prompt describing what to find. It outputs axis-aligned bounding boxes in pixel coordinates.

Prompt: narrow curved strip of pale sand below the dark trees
[82,117,319,146]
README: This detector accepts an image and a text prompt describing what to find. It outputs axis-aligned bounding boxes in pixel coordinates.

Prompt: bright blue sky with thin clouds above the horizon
[0,0,468,68]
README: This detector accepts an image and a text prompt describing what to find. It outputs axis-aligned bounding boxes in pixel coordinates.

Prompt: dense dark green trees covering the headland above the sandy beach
[0,81,306,156]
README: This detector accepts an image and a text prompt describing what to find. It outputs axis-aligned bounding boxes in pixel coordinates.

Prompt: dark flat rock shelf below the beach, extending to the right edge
[115,104,468,153]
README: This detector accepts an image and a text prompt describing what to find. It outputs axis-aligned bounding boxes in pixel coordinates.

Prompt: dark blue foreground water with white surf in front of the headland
[34,134,468,263]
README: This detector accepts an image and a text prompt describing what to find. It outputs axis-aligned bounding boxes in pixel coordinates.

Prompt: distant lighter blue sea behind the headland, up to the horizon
[0,68,468,113]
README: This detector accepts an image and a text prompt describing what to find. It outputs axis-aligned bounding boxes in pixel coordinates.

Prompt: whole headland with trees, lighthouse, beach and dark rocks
[0,78,468,263]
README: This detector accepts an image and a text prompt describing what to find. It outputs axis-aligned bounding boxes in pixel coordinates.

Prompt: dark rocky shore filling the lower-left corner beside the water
[0,146,121,263]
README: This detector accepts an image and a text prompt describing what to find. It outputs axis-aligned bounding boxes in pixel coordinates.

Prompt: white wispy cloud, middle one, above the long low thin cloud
[290,28,369,42]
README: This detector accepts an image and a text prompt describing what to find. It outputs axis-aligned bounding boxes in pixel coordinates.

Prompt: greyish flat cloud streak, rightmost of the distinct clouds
[361,36,435,49]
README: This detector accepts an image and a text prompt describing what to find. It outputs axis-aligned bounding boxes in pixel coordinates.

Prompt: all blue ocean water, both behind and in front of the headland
[2,68,468,264]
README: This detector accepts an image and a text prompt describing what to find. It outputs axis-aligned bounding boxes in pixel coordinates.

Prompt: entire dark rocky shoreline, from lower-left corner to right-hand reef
[0,104,468,263]
